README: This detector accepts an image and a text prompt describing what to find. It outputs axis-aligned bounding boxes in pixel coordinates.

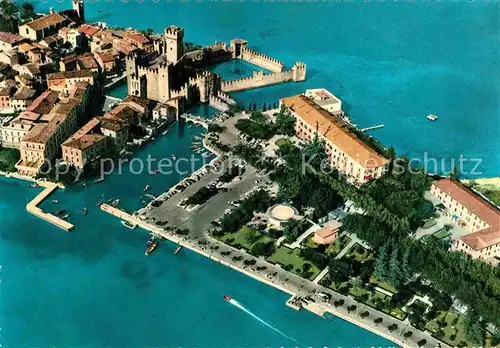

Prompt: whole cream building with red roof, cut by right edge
[431,179,500,260]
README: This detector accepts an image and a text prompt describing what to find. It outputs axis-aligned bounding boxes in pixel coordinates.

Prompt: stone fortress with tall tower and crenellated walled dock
[126,25,306,114]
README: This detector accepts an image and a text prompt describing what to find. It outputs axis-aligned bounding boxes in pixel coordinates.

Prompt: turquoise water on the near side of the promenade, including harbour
[0,125,391,347]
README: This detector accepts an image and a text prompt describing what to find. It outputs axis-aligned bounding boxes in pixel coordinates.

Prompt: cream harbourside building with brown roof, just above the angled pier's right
[61,118,107,169]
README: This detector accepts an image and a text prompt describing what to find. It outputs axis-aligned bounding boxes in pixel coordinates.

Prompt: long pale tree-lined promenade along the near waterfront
[101,204,447,347]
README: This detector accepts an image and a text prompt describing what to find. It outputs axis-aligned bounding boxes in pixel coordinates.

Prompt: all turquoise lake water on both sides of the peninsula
[0,1,500,347]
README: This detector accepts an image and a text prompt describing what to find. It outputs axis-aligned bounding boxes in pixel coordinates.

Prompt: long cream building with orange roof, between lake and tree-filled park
[280,95,389,184]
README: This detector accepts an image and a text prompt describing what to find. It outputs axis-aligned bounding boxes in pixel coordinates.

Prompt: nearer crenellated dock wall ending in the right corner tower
[221,62,306,93]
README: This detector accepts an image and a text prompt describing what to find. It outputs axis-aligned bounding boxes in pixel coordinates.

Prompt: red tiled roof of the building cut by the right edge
[433,179,500,250]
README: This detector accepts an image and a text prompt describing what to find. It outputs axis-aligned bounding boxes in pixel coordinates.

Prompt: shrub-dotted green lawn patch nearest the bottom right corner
[425,311,473,347]
